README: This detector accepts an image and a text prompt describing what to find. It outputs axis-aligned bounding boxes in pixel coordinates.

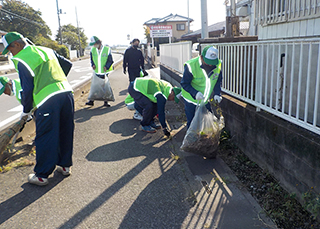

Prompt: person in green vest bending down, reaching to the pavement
[128,78,181,137]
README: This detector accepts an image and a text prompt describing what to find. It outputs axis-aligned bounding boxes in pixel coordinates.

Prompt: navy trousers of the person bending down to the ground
[128,82,158,126]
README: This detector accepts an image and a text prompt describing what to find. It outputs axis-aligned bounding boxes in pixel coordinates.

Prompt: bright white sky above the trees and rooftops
[22,0,226,46]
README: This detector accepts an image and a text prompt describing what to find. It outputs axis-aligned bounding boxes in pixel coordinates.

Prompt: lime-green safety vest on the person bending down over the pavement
[133,78,172,103]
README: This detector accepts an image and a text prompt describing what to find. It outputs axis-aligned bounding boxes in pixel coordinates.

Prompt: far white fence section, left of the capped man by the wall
[160,41,192,72]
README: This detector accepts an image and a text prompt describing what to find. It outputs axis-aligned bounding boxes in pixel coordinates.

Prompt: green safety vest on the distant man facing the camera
[91,46,112,74]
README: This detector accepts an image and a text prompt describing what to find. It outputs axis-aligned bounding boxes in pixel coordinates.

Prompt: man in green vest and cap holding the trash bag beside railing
[180,46,222,128]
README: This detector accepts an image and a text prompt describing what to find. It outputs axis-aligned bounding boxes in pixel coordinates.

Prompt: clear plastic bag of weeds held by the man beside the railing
[180,104,224,158]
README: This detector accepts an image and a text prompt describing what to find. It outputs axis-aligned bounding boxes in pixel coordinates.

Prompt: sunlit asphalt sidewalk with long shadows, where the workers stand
[0,65,276,229]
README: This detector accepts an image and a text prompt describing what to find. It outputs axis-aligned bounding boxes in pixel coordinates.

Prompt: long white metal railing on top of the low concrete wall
[160,38,320,134]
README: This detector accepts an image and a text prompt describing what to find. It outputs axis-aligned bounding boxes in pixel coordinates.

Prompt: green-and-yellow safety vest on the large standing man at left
[12,46,72,108]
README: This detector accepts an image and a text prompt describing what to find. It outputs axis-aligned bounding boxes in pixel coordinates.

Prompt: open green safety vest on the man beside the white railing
[181,57,221,105]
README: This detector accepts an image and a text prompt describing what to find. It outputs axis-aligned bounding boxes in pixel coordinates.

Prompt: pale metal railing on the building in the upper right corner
[255,0,320,25]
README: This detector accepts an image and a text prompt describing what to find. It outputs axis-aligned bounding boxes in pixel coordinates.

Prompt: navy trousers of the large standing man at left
[34,92,74,178]
